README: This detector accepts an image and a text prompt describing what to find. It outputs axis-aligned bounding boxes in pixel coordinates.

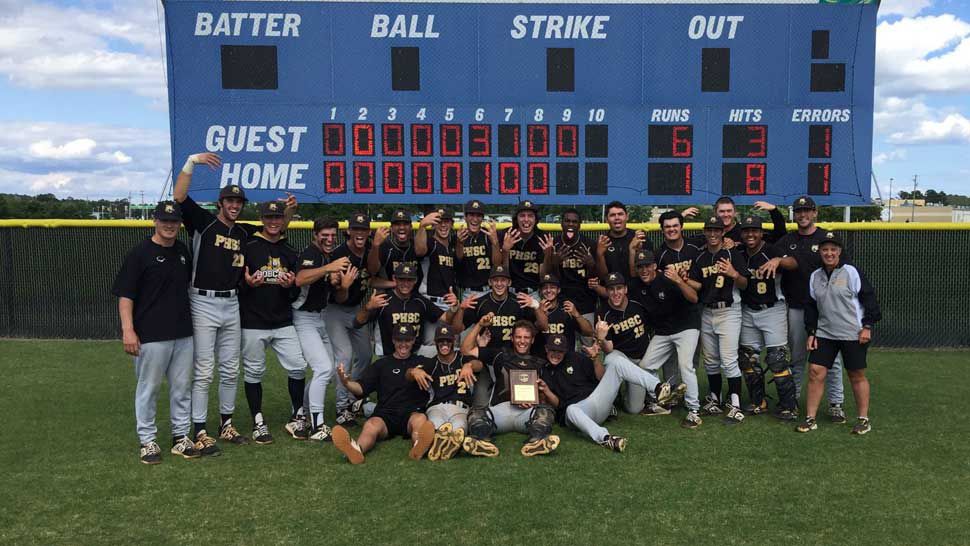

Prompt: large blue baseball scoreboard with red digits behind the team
[165,0,878,205]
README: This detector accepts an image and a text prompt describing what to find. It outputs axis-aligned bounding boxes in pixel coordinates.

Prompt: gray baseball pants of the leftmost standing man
[135,337,192,445]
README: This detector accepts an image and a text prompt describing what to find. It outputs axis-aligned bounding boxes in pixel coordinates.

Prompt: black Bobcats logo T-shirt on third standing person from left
[239,232,300,330]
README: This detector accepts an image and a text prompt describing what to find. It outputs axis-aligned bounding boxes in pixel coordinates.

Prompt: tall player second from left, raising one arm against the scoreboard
[172,153,296,456]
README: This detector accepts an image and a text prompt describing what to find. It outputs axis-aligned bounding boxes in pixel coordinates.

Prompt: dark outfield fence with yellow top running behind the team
[0,220,970,347]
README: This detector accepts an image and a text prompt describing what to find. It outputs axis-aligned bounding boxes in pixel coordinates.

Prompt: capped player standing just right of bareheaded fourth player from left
[323,212,373,426]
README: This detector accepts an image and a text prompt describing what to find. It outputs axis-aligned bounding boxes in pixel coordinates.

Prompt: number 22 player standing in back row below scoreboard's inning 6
[455,199,502,300]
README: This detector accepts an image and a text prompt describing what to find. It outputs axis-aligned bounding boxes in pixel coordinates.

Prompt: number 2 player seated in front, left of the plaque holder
[407,326,482,461]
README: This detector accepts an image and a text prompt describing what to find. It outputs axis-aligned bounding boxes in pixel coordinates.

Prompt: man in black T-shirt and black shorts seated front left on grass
[333,324,435,464]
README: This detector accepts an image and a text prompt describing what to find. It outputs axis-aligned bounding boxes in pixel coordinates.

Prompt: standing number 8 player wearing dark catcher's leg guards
[738,216,798,420]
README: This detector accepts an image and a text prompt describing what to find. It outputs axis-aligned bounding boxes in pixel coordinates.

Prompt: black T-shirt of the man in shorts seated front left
[357,355,428,415]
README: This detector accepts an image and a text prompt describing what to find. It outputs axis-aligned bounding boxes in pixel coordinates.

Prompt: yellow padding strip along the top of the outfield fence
[0,218,970,231]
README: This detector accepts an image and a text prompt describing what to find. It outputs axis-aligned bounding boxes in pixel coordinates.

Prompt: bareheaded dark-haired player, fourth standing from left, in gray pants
[293,218,356,441]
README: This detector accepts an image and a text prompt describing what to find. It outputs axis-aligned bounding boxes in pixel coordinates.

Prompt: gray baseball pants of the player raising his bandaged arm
[189,290,242,423]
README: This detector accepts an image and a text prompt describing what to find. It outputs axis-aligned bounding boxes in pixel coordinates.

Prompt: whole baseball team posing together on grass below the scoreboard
[112,153,880,464]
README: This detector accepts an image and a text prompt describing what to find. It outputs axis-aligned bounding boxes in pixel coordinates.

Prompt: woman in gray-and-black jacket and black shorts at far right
[796,233,882,434]
